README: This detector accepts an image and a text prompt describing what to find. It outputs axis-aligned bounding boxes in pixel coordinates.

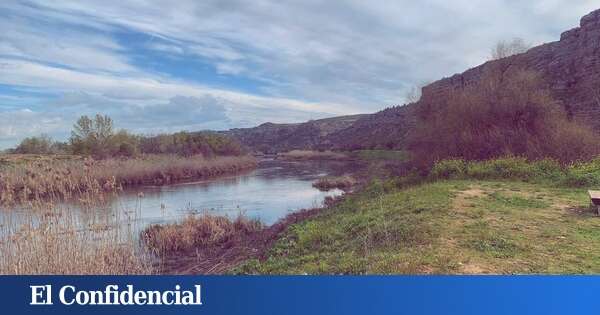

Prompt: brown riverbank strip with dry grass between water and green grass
[142,198,341,275]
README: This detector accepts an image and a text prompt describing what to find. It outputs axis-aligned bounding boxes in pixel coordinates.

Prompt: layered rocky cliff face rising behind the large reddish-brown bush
[422,10,600,130]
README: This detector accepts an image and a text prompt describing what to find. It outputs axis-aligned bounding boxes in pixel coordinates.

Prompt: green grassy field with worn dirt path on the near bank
[235,180,600,274]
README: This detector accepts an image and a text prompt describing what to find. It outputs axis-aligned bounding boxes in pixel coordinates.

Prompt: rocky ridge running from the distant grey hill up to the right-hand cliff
[228,10,600,151]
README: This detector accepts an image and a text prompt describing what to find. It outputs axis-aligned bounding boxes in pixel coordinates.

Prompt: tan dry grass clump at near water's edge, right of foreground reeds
[142,214,263,256]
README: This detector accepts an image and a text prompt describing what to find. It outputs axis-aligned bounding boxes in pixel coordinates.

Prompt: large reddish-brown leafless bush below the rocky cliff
[410,68,600,166]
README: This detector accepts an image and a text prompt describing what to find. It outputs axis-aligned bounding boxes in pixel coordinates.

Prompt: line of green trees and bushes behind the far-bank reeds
[9,114,245,158]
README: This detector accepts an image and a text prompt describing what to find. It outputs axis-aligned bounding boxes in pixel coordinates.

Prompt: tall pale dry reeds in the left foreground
[0,191,154,275]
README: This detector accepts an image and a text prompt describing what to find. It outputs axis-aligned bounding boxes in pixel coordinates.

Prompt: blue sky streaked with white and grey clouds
[0,0,600,149]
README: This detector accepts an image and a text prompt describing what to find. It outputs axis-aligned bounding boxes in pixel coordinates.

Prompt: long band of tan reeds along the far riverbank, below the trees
[0,155,256,204]
